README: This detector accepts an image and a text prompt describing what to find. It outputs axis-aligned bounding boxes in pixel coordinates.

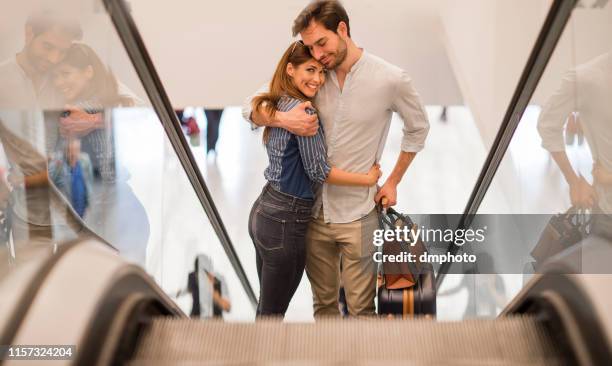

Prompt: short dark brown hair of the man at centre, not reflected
[292,0,351,37]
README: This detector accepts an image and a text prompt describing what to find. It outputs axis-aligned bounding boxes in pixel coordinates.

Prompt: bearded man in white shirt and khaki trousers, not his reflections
[243,0,429,317]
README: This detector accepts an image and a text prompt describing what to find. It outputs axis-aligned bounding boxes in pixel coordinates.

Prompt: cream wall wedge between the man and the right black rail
[439,0,550,146]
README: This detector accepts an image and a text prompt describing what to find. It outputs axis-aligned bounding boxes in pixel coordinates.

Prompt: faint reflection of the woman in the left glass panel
[53,43,149,264]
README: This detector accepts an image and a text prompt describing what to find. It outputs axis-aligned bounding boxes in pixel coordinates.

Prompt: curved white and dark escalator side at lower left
[7,241,184,364]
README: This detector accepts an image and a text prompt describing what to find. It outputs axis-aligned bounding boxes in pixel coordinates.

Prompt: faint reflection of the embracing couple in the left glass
[0,13,148,260]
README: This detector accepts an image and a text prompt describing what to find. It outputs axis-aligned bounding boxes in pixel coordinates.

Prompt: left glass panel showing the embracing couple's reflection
[0,0,252,319]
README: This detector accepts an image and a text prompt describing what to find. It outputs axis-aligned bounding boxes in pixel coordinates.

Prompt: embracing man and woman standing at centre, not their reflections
[243,1,429,316]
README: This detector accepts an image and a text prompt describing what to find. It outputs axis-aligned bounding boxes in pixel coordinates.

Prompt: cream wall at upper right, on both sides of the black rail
[438,0,612,146]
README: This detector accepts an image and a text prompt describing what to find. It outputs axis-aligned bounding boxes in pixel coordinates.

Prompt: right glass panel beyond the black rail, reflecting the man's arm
[479,1,612,316]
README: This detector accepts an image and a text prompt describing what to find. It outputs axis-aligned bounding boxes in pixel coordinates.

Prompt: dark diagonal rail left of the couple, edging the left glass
[103,0,257,308]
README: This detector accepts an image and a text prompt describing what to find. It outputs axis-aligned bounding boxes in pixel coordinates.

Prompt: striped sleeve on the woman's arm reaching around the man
[296,129,331,184]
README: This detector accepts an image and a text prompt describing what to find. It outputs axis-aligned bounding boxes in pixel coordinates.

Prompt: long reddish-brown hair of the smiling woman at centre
[253,41,312,144]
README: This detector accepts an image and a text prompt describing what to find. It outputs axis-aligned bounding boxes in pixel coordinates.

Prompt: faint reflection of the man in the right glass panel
[538,53,612,219]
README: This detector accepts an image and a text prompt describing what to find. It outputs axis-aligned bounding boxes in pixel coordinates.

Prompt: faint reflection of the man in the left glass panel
[0,14,82,246]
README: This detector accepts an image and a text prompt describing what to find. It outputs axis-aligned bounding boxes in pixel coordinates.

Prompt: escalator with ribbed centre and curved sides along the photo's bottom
[2,236,611,365]
